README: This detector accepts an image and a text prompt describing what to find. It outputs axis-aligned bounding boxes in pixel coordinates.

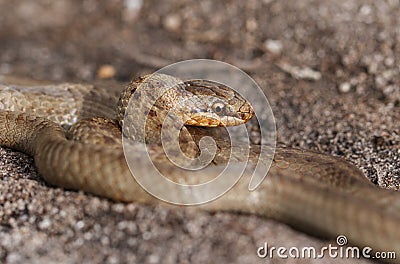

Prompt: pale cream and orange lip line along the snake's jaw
[185,113,251,127]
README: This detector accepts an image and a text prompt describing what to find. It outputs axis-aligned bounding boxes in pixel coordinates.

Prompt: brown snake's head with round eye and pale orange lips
[185,80,254,127]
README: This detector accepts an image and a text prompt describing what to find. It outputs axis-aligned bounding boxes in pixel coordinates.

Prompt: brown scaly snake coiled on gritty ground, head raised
[0,75,400,263]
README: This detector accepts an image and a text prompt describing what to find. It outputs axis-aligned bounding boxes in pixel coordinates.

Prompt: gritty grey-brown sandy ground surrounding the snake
[0,0,400,263]
